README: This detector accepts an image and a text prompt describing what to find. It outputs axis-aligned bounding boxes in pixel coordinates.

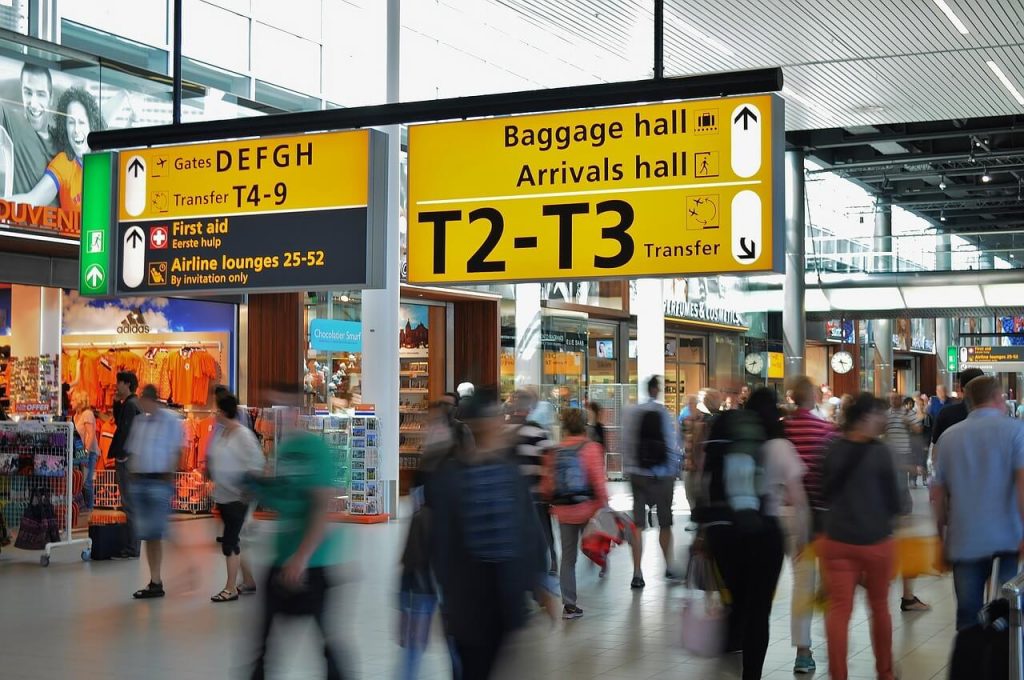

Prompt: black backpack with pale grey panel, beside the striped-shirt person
[693,410,767,532]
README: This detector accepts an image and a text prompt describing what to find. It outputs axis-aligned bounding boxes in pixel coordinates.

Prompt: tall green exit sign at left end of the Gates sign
[78,153,114,296]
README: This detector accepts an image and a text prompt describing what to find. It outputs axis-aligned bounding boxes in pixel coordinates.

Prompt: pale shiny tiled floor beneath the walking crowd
[0,485,953,680]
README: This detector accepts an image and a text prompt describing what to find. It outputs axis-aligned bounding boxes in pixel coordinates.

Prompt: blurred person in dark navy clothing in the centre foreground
[424,390,548,680]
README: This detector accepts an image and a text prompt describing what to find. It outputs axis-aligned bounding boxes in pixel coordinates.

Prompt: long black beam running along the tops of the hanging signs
[89,69,782,151]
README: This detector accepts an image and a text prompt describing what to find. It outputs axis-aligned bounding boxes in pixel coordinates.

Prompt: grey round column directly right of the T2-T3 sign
[782,151,807,379]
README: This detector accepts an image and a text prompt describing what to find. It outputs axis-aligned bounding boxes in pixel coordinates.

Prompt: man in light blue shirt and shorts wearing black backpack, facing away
[623,376,682,588]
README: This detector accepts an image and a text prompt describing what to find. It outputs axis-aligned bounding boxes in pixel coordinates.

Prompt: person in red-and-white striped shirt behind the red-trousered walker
[783,376,835,674]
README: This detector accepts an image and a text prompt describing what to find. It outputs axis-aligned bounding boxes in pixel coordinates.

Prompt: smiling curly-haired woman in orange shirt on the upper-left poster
[13,87,104,218]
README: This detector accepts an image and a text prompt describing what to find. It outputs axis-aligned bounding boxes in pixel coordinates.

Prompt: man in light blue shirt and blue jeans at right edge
[932,376,1024,630]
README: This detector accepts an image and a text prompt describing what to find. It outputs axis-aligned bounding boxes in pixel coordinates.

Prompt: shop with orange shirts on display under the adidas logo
[0,284,239,524]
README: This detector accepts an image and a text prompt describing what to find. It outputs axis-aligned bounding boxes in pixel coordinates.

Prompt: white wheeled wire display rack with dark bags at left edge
[0,421,92,566]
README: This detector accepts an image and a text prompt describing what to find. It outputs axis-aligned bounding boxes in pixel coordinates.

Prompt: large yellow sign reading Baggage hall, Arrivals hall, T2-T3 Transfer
[408,95,784,284]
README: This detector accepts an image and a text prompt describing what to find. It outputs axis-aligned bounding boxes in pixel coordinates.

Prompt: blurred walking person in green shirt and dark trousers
[248,386,345,680]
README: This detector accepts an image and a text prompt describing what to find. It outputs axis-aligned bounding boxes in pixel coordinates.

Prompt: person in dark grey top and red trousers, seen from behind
[820,392,901,680]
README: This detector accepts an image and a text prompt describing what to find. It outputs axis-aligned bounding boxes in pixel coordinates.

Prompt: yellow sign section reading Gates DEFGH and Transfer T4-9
[118,130,370,221]
